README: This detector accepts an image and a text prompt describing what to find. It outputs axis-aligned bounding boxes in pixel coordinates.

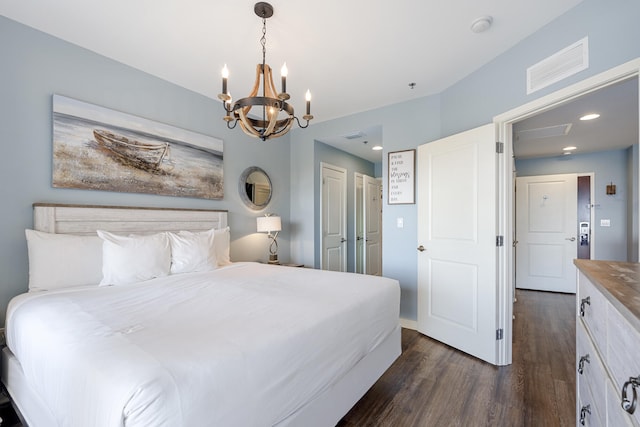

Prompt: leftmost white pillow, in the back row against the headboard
[25,230,102,291]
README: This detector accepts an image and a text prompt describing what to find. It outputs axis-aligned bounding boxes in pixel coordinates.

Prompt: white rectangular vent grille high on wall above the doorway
[527,37,589,94]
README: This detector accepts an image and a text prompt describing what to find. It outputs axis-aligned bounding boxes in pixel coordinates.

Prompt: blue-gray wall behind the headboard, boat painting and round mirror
[0,17,290,323]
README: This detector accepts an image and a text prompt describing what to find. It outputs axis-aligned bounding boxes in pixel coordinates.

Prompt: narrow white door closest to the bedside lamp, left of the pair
[320,163,347,271]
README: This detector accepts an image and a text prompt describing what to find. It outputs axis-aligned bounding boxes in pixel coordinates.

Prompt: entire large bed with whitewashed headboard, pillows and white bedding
[2,204,401,427]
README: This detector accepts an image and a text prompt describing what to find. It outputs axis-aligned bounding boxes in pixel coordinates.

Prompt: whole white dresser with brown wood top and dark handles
[575,260,640,427]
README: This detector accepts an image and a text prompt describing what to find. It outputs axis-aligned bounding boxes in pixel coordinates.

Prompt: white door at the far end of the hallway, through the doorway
[516,173,578,293]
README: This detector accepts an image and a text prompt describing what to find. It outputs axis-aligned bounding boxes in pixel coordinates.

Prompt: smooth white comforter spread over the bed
[6,263,400,427]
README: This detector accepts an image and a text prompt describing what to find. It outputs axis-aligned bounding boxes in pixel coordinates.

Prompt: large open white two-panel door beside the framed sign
[417,124,499,364]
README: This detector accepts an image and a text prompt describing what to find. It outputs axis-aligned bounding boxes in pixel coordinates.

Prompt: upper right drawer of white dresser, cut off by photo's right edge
[606,310,640,424]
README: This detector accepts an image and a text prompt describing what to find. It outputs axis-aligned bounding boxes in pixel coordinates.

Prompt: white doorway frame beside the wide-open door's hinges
[493,58,640,365]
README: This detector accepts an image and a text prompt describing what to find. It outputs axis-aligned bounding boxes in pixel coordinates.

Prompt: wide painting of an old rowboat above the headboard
[52,95,224,199]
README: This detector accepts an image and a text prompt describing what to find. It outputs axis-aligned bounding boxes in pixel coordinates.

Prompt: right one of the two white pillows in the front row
[167,230,217,274]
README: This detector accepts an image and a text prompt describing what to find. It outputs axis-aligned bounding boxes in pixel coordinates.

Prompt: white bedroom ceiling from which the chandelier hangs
[0,0,581,160]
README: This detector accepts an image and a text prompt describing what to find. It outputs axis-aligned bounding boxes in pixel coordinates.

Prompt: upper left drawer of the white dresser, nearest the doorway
[576,272,609,353]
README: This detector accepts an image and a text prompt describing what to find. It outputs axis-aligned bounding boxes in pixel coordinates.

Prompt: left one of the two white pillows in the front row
[98,230,171,285]
